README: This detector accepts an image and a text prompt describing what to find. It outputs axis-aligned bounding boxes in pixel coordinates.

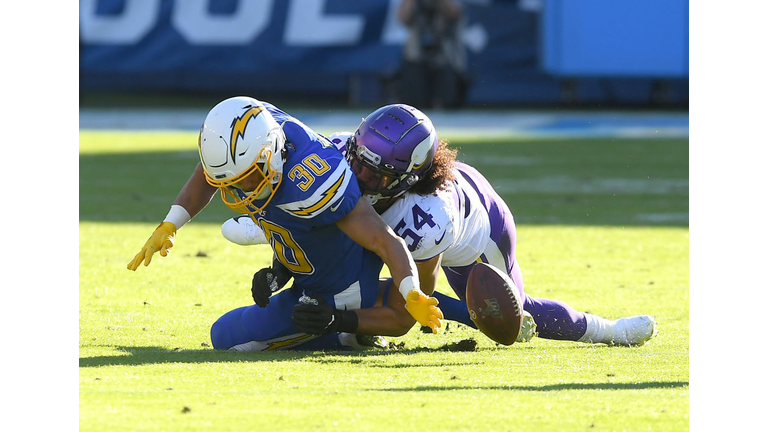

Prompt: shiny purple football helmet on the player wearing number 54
[347,104,438,204]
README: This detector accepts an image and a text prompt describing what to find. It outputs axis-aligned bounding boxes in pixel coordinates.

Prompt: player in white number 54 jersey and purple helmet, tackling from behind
[222,104,657,346]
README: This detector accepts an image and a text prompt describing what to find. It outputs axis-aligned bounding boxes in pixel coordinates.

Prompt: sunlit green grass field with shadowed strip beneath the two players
[79,131,689,431]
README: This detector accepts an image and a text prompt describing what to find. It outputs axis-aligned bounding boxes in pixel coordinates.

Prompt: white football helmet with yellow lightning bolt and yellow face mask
[198,96,285,215]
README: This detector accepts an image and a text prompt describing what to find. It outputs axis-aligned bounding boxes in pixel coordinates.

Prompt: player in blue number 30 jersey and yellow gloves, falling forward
[128,97,443,351]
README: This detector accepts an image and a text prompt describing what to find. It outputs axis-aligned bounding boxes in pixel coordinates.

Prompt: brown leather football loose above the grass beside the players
[467,263,523,345]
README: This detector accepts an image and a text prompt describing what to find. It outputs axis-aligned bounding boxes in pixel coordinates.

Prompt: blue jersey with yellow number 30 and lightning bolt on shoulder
[237,103,383,294]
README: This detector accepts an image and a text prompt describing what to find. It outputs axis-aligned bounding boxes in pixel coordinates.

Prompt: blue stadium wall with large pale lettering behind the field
[80,0,688,107]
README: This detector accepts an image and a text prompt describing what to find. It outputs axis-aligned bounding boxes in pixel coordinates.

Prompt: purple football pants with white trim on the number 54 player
[437,164,587,341]
